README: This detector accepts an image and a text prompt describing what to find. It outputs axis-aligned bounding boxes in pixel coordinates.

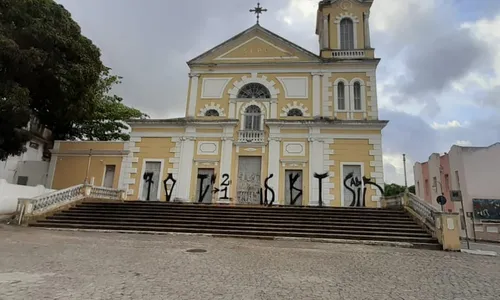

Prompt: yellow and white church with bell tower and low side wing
[48,0,387,207]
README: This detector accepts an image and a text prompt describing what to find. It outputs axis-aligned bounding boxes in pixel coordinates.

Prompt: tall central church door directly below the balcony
[236,156,261,204]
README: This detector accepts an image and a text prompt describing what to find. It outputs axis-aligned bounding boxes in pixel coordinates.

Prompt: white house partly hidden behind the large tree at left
[0,119,51,186]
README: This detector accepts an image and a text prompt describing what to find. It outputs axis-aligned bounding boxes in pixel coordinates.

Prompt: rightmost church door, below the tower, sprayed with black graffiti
[342,165,365,207]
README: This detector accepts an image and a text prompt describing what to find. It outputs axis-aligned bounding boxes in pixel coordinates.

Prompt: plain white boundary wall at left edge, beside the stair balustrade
[0,179,54,219]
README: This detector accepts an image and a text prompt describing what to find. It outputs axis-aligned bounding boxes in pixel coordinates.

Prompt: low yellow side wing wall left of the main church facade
[52,142,124,189]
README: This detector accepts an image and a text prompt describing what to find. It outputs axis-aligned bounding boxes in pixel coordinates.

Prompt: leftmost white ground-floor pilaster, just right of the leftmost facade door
[176,137,196,202]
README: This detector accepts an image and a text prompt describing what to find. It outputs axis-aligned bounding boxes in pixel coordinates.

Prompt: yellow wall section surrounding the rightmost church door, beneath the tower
[330,139,377,207]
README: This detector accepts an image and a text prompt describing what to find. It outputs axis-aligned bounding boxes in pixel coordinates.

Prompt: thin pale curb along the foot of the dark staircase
[40,227,418,247]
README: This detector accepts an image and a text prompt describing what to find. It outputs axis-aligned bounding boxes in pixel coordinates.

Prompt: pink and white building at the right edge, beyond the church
[413,143,500,241]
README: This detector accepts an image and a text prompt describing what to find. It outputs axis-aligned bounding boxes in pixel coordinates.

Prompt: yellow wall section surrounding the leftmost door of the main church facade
[129,137,175,201]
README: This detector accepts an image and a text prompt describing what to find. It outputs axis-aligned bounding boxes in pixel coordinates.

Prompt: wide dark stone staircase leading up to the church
[29,200,441,249]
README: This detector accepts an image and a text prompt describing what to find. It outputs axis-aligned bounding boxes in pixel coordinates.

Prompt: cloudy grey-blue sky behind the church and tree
[56,0,500,184]
